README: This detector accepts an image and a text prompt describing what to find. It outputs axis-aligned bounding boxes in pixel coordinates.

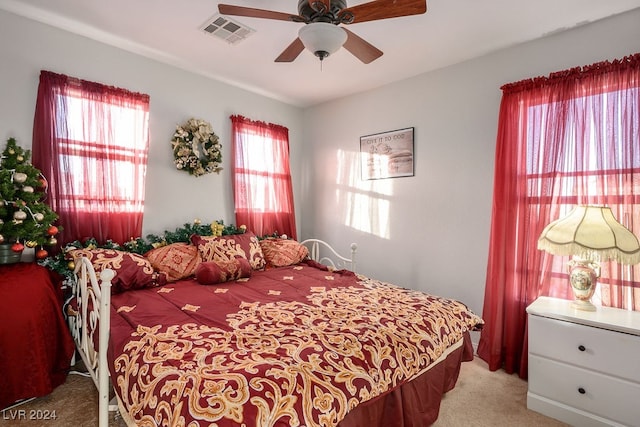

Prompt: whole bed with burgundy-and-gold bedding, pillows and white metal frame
[70,233,483,427]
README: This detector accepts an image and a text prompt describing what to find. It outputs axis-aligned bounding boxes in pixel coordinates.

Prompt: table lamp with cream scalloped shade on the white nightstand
[538,206,640,311]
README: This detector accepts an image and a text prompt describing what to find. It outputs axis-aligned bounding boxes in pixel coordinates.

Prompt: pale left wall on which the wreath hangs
[0,8,303,235]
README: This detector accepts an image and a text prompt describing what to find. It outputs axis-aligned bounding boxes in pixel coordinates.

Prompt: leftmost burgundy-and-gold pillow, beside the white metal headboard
[69,249,167,293]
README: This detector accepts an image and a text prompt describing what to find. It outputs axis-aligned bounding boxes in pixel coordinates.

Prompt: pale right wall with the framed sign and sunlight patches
[302,10,640,320]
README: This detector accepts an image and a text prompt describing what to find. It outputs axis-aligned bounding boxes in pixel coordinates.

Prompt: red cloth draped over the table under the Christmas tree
[0,263,75,409]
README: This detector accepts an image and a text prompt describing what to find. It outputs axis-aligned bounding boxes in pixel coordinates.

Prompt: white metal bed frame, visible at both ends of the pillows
[68,239,358,427]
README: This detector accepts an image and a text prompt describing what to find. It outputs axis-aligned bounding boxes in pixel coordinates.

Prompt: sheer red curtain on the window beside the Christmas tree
[32,71,149,245]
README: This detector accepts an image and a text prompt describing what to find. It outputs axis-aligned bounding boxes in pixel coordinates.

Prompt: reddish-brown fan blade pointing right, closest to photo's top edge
[340,0,427,24]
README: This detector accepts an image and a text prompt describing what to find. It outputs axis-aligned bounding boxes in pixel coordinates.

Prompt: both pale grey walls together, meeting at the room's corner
[0,5,640,324]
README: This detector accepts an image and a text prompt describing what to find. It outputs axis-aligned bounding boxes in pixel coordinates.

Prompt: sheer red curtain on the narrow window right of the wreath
[231,115,297,239]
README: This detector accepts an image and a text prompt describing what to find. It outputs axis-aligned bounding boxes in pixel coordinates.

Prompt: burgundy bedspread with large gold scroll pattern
[109,261,482,427]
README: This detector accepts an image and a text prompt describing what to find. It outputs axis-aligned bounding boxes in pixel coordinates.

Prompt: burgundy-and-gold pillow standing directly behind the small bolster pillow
[191,232,267,270]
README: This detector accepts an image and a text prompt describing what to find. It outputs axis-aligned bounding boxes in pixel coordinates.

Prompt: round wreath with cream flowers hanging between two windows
[171,119,222,176]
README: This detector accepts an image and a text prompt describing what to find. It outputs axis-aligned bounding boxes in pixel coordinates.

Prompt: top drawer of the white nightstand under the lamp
[529,316,640,382]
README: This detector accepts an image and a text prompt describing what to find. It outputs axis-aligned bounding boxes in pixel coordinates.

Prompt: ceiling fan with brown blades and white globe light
[218,0,427,64]
